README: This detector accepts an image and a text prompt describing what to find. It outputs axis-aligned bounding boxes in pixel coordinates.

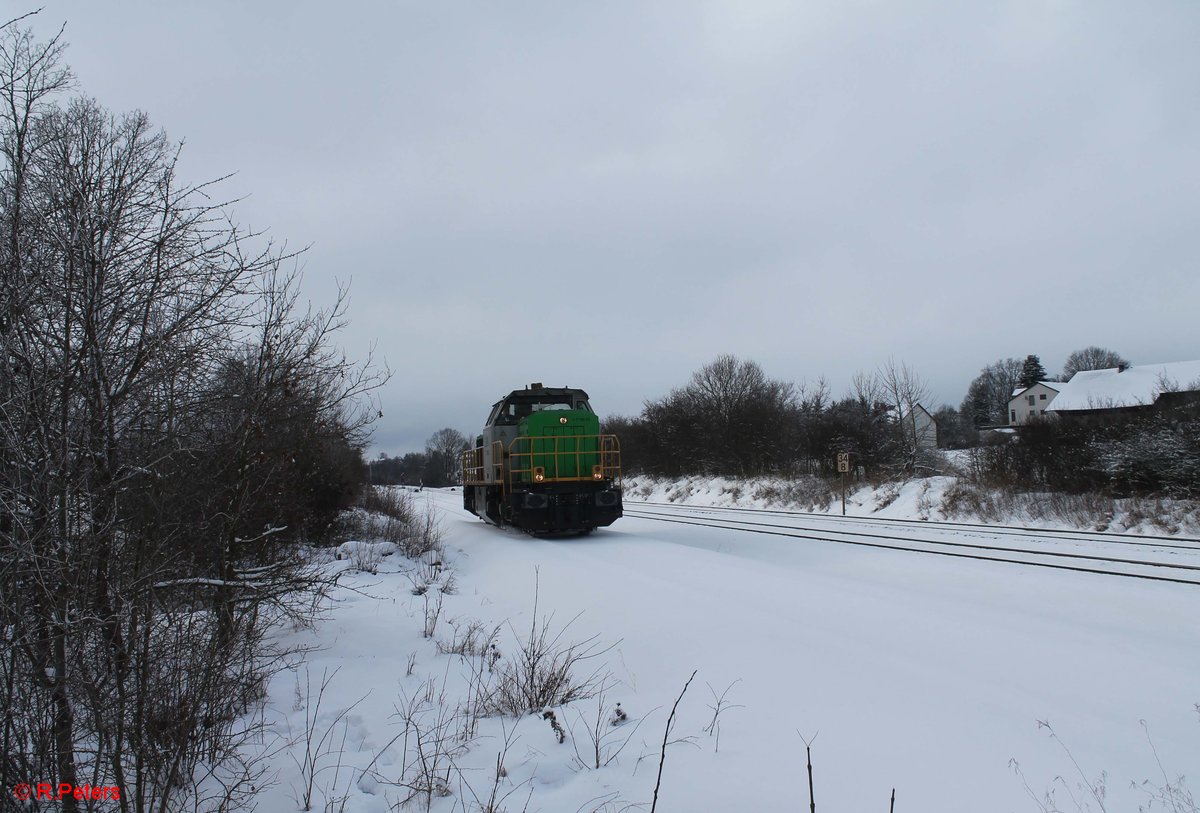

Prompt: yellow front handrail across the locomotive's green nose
[505,435,620,490]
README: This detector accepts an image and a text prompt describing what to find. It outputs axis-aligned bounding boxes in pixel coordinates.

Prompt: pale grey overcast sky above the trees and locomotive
[25,0,1200,453]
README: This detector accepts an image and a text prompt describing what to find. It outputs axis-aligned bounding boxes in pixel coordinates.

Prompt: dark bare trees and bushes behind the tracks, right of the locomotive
[604,348,1200,498]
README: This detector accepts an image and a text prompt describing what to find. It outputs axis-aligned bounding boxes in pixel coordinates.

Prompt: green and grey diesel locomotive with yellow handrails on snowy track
[462,384,622,532]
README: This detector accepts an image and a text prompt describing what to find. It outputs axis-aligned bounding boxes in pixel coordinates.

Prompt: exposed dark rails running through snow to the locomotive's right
[625,501,1200,586]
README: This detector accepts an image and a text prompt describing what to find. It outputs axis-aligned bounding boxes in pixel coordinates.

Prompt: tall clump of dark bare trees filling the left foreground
[0,22,379,812]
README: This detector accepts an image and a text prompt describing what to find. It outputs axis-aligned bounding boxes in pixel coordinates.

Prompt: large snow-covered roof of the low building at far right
[1046,361,1200,412]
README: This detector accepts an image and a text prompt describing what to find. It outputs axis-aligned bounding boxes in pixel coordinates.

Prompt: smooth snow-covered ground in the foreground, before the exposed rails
[259,490,1200,813]
